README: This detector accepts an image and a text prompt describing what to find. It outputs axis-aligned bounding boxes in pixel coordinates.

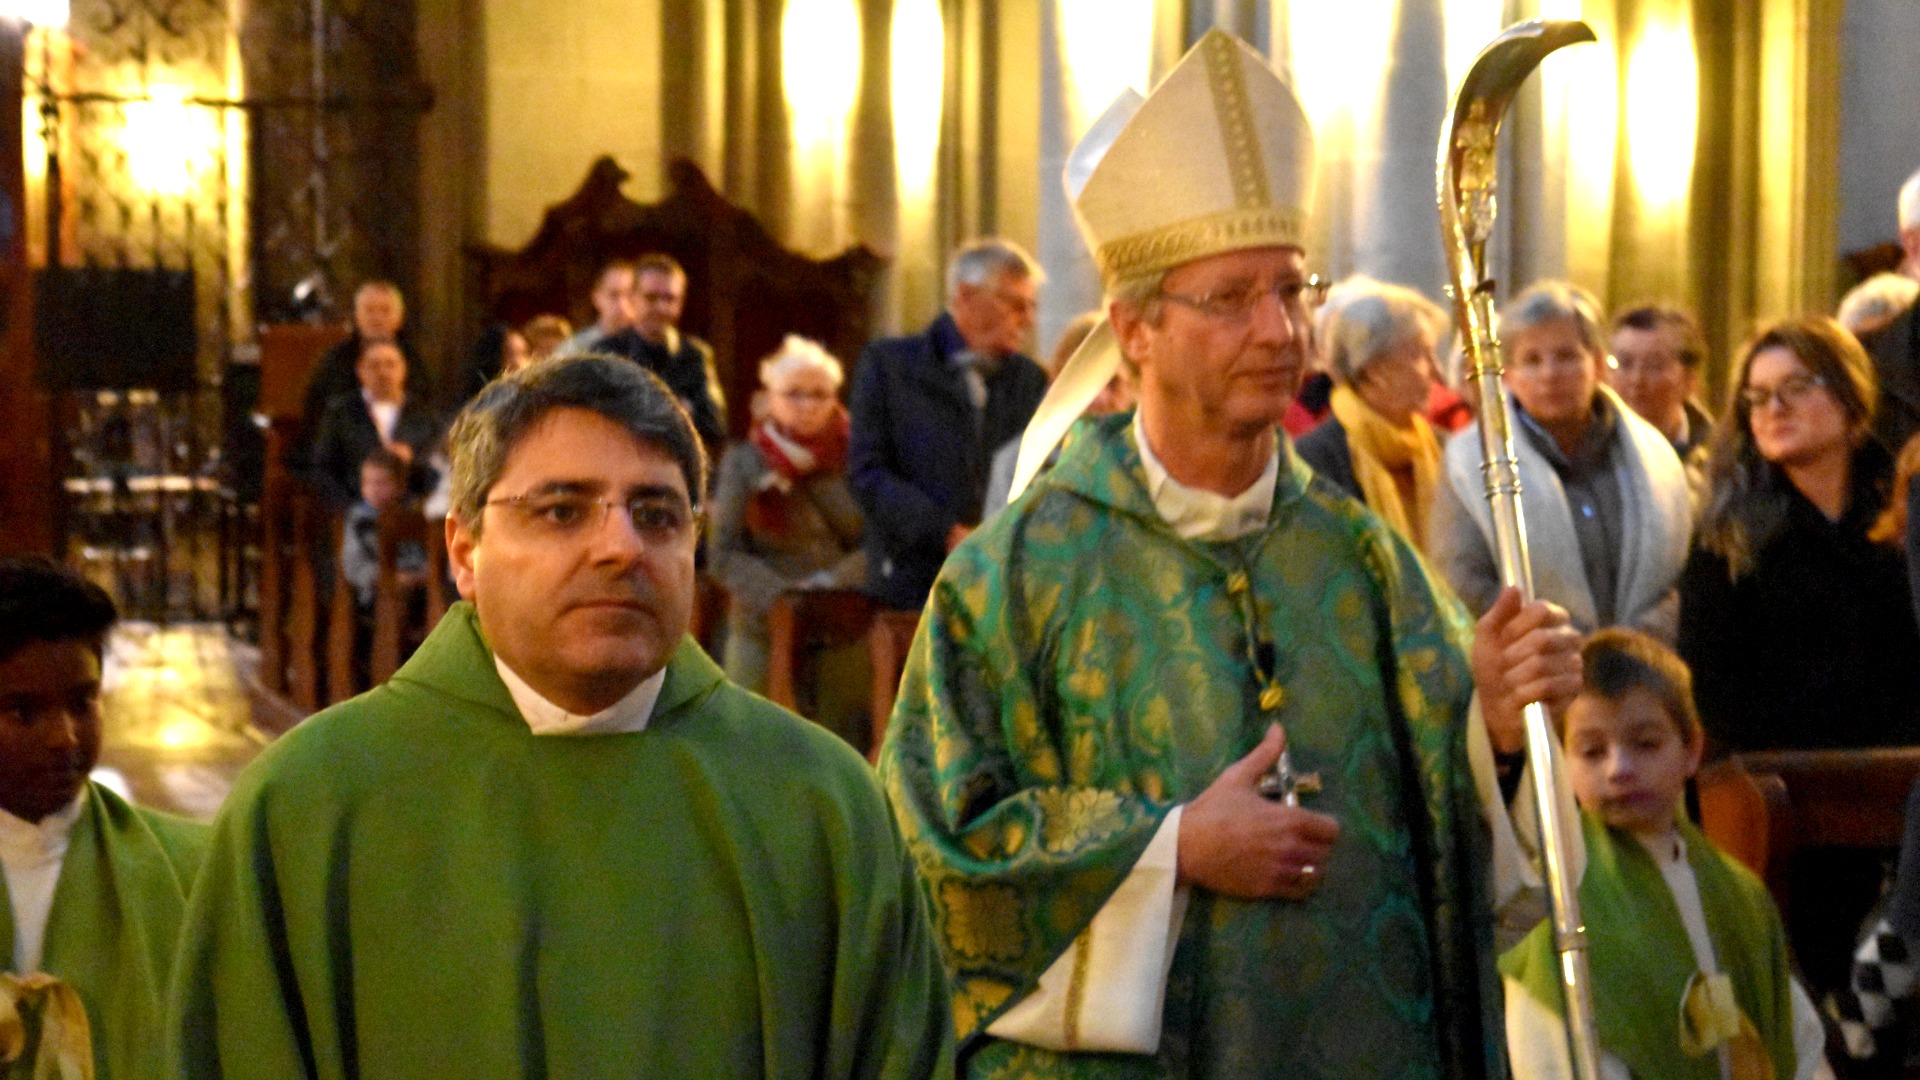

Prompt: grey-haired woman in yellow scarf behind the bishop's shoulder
[1296,277,1448,552]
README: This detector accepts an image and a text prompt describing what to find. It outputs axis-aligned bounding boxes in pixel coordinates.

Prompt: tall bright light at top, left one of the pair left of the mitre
[780,0,860,152]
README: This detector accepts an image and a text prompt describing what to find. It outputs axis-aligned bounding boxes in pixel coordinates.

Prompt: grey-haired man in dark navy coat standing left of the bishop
[847,238,1046,611]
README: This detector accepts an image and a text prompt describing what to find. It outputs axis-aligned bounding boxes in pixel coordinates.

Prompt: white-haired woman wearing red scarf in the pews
[708,334,866,707]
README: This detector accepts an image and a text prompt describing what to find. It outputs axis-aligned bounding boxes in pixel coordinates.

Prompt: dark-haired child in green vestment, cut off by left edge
[0,559,207,1080]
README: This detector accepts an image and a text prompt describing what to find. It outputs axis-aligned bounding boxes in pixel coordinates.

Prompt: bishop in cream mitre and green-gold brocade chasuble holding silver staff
[881,33,1580,1080]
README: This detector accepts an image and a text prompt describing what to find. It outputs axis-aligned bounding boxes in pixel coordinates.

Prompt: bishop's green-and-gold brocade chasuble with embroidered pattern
[881,417,1505,1078]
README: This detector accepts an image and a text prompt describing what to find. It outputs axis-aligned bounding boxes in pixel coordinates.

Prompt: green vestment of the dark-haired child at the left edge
[0,780,207,1080]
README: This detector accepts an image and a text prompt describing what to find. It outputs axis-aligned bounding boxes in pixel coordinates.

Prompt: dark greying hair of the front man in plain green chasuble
[447,352,707,536]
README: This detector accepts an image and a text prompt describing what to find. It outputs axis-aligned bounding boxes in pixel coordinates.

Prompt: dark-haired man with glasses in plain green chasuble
[171,356,952,1080]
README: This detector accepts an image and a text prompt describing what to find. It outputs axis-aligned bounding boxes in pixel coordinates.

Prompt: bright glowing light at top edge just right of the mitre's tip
[1286,0,1397,135]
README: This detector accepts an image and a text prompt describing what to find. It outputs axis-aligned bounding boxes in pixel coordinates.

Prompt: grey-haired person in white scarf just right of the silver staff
[1428,281,1693,644]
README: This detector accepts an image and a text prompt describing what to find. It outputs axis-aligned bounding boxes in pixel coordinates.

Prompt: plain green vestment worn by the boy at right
[1500,813,1797,1080]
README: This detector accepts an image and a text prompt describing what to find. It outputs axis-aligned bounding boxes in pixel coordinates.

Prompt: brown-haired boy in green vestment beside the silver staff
[1500,628,1826,1080]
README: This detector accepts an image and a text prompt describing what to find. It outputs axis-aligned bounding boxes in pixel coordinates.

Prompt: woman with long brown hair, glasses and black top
[1680,317,1920,749]
